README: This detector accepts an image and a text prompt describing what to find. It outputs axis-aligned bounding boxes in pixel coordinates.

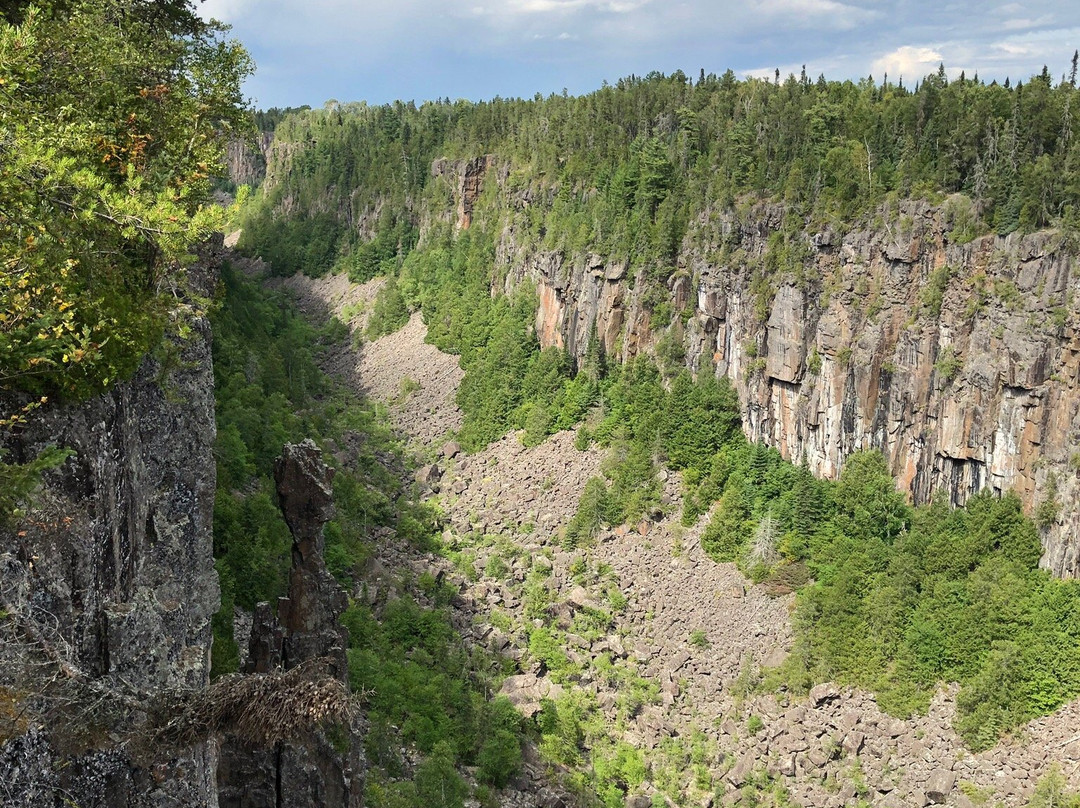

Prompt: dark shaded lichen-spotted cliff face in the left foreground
[0,243,219,808]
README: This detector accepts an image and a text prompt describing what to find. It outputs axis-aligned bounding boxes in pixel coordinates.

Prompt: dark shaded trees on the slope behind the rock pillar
[212,265,399,674]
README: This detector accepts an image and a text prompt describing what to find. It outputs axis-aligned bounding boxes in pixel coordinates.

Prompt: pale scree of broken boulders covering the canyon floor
[283,260,1080,808]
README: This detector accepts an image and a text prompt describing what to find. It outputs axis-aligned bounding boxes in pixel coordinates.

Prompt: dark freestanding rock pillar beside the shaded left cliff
[218,440,364,808]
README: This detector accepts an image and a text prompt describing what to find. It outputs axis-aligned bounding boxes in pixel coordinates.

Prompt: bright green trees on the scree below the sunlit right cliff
[567,354,1080,749]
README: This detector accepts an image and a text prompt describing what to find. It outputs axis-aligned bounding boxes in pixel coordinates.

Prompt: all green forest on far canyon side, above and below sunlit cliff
[232,58,1080,748]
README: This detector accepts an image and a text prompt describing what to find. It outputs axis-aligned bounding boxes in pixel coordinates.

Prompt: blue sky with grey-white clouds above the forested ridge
[200,0,1080,109]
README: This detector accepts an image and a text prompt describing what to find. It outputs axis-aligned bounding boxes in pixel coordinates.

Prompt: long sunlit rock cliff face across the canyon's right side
[488,192,1080,577]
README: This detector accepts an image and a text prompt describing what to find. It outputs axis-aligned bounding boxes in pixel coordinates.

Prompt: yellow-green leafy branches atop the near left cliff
[0,0,251,512]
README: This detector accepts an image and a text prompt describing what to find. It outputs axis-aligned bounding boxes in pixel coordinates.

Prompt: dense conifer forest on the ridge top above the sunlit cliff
[244,59,1080,278]
